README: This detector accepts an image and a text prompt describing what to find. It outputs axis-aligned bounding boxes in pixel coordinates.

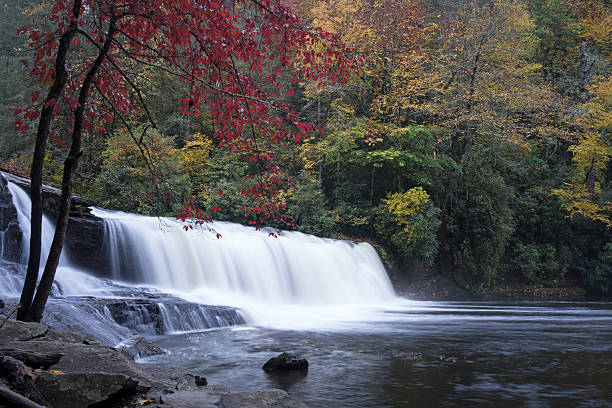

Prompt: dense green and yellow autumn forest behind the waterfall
[0,0,612,294]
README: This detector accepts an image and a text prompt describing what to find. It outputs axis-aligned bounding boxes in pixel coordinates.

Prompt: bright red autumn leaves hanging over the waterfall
[15,0,353,231]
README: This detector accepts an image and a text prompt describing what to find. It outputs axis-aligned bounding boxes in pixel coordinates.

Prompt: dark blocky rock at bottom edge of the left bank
[36,372,138,408]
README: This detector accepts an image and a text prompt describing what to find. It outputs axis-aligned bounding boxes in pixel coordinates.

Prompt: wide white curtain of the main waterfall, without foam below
[92,208,394,306]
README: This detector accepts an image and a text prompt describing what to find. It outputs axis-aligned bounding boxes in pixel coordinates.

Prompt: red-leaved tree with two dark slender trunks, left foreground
[15,0,350,321]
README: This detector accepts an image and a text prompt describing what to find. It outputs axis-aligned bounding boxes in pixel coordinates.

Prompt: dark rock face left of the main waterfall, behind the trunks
[0,173,111,277]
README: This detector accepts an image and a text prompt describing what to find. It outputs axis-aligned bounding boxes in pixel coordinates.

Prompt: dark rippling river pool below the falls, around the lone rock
[143,302,612,408]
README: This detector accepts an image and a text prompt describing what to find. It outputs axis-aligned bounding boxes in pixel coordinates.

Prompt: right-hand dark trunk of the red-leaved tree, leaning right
[29,13,117,322]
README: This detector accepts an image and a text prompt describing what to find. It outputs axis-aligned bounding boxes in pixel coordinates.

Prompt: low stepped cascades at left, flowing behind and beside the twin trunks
[0,182,244,345]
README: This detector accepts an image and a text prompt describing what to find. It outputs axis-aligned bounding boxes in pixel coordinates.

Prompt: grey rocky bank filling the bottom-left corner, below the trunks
[0,317,307,408]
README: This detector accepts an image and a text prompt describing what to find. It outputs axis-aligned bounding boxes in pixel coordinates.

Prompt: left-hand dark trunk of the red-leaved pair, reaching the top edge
[17,0,81,321]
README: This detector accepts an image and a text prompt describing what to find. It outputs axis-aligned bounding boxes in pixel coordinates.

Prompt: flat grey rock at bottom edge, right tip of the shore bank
[221,389,308,408]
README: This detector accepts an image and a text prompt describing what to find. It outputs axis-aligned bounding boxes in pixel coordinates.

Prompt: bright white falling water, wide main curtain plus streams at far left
[0,178,397,329]
